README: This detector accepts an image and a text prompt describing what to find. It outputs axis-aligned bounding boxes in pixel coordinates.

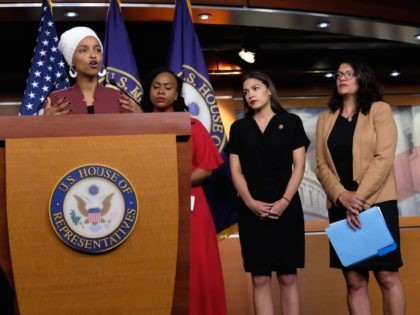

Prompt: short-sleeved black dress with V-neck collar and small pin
[226,113,309,275]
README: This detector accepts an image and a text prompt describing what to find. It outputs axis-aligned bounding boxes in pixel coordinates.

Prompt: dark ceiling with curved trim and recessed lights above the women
[0,1,420,100]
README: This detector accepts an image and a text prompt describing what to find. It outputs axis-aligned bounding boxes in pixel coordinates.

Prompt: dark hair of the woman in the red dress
[140,67,188,113]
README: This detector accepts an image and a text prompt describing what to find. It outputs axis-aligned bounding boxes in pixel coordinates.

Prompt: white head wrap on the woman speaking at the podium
[58,26,103,67]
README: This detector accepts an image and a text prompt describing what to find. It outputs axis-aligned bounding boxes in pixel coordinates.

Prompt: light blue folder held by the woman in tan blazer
[325,207,397,267]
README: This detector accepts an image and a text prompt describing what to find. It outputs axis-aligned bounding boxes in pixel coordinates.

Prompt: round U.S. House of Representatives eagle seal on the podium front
[49,165,138,254]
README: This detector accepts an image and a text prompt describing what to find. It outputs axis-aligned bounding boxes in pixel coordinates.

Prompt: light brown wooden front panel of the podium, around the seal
[6,135,179,315]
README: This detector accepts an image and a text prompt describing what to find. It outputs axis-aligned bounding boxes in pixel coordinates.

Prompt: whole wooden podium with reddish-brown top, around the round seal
[0,113,191,315]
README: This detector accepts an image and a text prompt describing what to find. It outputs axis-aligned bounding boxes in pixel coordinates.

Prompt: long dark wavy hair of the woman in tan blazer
[328,57,383,114]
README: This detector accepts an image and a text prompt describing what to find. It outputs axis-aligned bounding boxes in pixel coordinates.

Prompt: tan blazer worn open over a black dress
[315,102,398,209]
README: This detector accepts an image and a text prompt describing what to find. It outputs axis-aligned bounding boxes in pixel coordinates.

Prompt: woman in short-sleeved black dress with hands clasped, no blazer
[226,72,309,315]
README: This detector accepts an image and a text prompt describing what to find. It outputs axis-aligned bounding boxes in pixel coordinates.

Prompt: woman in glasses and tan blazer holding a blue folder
[316,59,405,314]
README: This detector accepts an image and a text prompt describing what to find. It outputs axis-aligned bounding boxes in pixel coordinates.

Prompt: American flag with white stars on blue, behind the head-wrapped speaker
[19,0,70,115]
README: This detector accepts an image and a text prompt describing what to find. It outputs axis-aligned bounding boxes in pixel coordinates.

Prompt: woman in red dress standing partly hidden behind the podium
[141,68,227,315]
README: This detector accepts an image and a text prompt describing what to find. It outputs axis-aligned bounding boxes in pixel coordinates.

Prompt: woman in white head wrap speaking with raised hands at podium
[43,26,141,115]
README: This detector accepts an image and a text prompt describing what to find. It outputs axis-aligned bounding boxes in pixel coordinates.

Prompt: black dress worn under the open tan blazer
[328,114,402,270]
